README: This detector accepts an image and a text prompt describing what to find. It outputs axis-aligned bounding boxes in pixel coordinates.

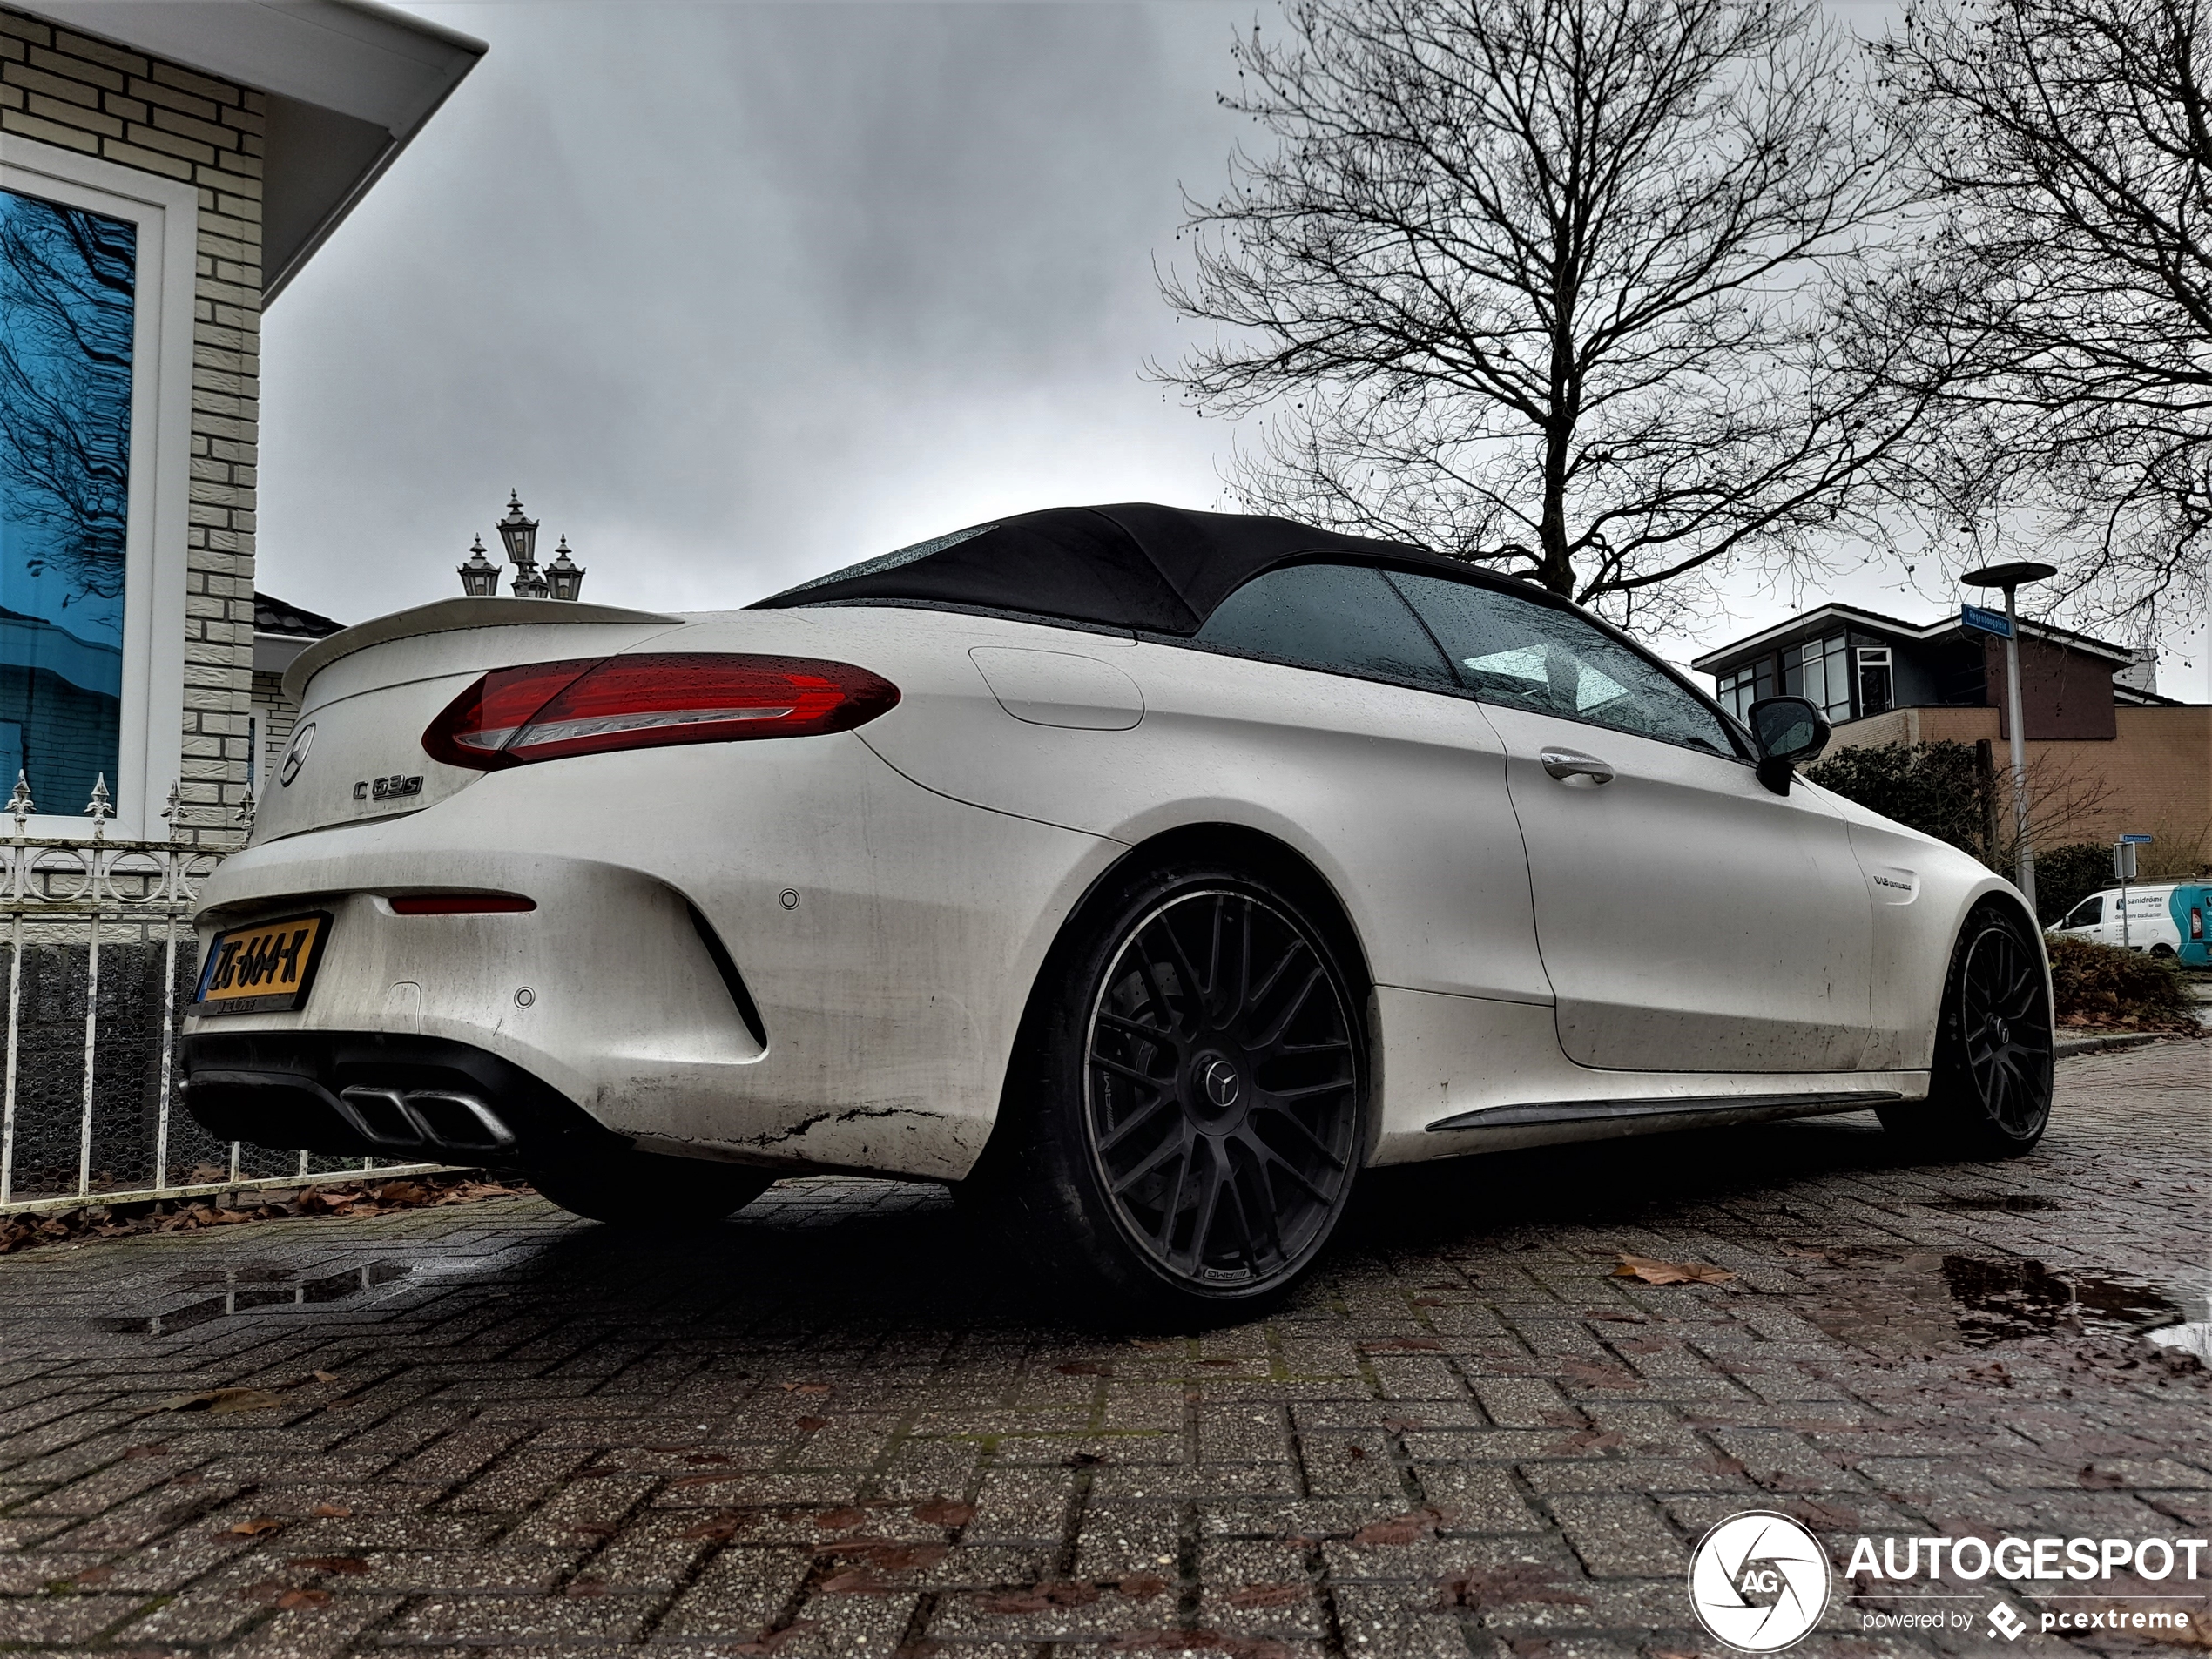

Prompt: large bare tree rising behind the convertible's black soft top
[1150,0,1929,619]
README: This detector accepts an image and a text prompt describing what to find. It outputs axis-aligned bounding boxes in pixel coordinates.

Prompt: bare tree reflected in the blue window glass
[0,192,137,606]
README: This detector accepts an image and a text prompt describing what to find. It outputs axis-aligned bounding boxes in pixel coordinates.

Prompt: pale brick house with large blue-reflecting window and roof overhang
[0,0,484,847]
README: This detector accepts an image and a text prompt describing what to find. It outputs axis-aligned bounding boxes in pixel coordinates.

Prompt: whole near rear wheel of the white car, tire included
[962,860,1369,1330]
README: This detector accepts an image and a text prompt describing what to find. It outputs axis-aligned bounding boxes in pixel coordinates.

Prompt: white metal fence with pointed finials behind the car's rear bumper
[0,774,435,1212]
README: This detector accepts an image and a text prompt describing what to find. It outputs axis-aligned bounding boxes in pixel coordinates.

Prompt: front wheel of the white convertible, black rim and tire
[1880,905,2053,1162]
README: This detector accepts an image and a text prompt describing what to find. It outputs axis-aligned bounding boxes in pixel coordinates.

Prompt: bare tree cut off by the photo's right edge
[1883,0,2212,626]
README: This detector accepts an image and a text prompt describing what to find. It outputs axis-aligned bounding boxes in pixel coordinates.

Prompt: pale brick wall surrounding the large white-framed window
[0,7,266,847]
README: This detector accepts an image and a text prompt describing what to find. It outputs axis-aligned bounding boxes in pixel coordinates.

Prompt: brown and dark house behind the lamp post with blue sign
[1692,604,2212,865]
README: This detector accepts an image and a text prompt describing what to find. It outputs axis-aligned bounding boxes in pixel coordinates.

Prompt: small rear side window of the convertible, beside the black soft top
[1195,564,1458,690]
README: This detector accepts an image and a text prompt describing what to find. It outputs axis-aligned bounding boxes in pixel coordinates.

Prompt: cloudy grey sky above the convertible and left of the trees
[259,0,2208,699]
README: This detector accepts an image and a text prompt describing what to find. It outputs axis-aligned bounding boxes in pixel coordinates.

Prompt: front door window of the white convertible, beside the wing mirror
[1389,570,1737,757]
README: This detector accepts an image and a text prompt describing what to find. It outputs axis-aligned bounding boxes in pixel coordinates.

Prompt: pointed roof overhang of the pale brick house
[9,0,484,303]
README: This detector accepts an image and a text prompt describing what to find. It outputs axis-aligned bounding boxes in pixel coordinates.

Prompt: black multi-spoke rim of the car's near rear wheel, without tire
[1084,889,1360,1287]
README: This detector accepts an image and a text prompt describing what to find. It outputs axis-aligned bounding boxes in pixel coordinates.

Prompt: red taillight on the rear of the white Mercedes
[422,652,898,772]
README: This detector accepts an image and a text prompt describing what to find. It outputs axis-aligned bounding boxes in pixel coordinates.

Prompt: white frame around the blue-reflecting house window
[0,132,199,840]
